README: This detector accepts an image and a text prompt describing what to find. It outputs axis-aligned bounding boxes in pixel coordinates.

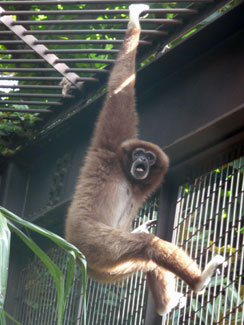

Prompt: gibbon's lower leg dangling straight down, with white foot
[147,267,186,315]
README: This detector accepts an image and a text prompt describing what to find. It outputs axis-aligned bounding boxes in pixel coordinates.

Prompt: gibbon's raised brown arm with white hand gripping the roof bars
[92,5,149,151]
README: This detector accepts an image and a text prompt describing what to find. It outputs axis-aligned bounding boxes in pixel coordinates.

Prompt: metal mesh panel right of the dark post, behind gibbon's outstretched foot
[162,158,244,325]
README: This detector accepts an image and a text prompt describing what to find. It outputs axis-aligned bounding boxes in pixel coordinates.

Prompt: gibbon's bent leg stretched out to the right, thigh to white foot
[72,219,224,292]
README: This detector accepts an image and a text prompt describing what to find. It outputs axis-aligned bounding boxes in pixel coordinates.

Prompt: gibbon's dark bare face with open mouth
[130,148,157,180]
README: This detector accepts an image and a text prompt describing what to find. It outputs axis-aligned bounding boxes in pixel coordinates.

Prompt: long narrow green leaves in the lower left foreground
[0,207,86,325]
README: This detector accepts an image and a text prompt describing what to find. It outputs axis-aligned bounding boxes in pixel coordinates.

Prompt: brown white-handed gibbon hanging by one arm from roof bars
[66,5,224,315]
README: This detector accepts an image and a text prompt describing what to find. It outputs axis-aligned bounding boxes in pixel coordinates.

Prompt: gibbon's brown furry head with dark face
[119,139,169,183]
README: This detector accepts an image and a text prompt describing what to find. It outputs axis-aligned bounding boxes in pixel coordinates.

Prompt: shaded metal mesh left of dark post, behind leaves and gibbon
[14,194,158,325]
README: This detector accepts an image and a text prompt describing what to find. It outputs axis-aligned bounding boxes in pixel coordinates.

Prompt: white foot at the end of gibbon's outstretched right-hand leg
[194,255,227,294]
